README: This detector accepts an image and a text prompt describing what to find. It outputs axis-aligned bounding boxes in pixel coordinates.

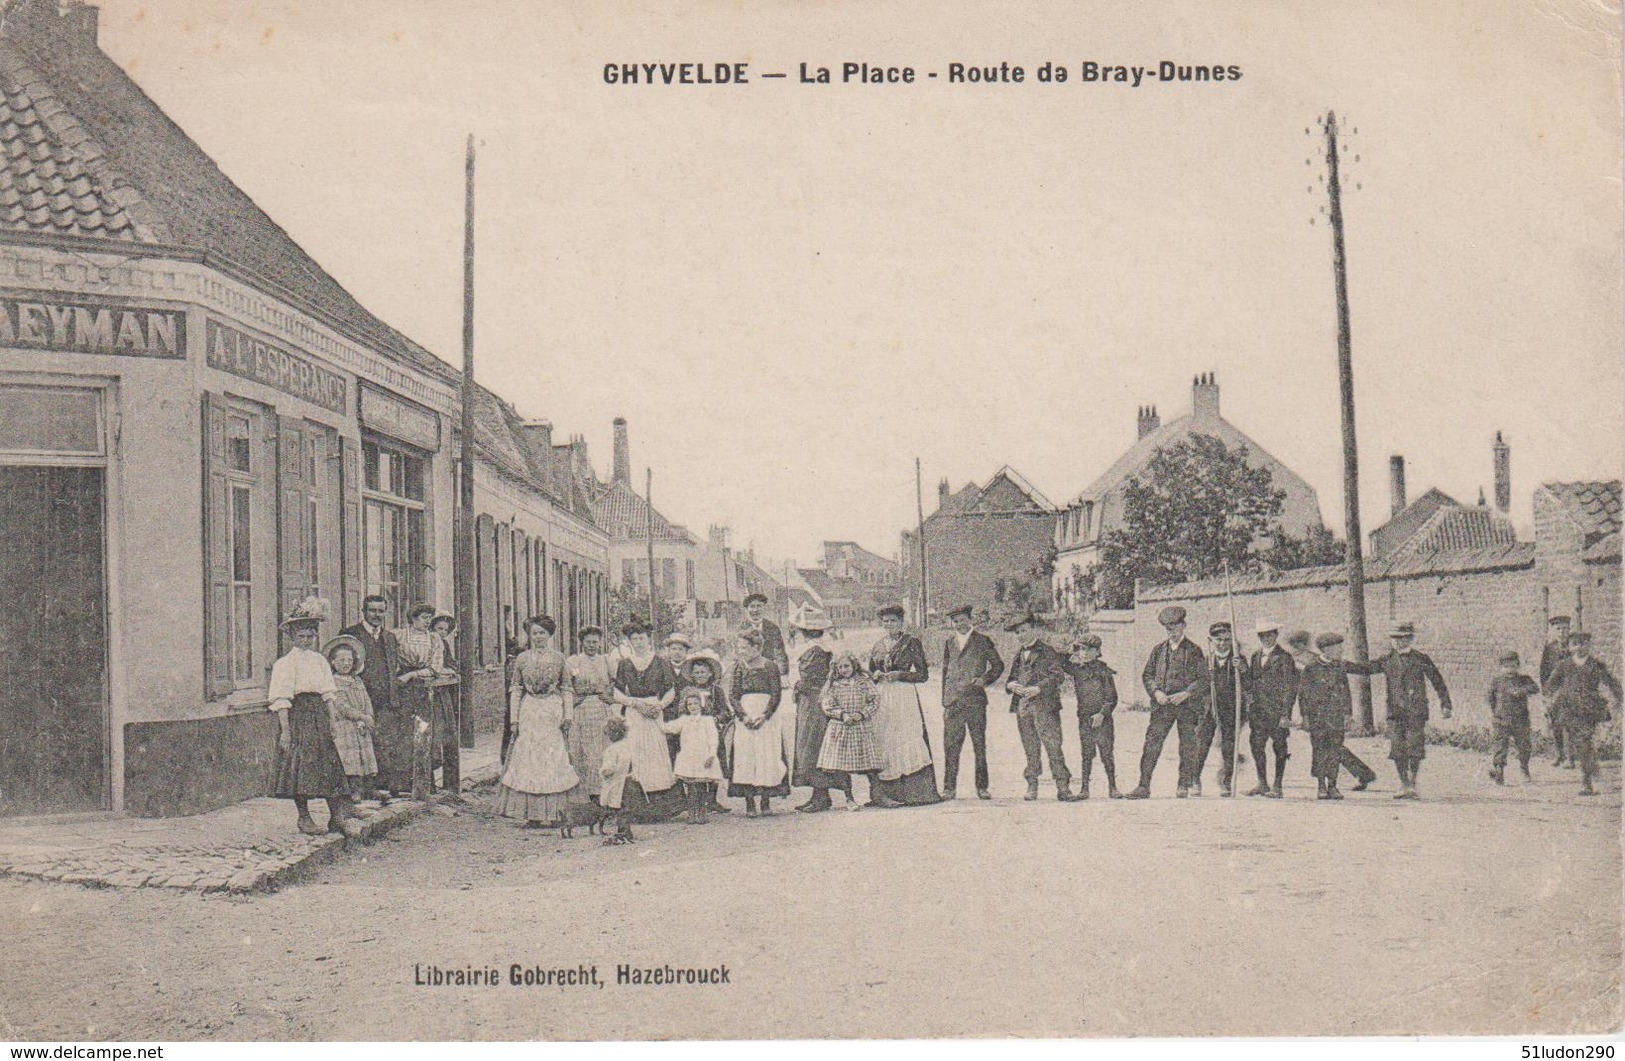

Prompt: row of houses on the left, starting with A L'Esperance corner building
[0,0,819,816]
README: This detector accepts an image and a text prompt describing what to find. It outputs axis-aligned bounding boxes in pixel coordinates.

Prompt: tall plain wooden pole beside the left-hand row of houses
[440,133,478,793]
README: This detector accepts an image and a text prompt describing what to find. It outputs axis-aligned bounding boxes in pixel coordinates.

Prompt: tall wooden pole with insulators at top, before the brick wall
[1326,110,1376,734]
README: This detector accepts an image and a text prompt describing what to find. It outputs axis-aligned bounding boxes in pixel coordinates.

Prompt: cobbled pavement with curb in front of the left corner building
[0,801,431,895]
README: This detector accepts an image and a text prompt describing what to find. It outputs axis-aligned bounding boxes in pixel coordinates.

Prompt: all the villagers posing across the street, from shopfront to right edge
[270,593,1620,843]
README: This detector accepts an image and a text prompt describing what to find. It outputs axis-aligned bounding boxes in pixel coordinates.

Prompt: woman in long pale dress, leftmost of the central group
[497,616,582,829]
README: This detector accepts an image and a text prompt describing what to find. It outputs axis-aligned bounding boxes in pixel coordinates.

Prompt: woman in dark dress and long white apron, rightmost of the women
[869,604,943,808]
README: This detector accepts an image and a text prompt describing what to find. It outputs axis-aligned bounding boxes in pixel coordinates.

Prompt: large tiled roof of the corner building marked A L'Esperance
[0,0,457,382]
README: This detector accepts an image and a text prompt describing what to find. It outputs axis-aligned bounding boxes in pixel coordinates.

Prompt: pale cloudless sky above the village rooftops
[101,0,1625,564]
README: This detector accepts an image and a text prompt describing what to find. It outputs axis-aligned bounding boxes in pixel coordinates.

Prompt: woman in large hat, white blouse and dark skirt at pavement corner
[270,596,361,835]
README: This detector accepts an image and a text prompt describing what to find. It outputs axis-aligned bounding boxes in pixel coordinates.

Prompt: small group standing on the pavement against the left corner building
[268,595,457,835]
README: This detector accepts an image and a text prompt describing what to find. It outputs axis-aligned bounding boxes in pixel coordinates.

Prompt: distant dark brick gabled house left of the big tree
[902,465,1055,617]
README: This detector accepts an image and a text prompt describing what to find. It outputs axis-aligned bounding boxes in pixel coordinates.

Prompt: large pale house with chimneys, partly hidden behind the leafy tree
[1053,372,1324,611]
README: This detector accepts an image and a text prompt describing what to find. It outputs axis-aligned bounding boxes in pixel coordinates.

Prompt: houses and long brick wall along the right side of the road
[902,374,1622,737]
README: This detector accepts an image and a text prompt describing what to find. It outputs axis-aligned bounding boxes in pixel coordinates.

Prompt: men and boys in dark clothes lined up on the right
[968,606,1620,801]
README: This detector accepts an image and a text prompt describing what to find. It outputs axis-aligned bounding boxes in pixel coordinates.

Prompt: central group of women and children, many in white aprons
[496,593,939,843]
